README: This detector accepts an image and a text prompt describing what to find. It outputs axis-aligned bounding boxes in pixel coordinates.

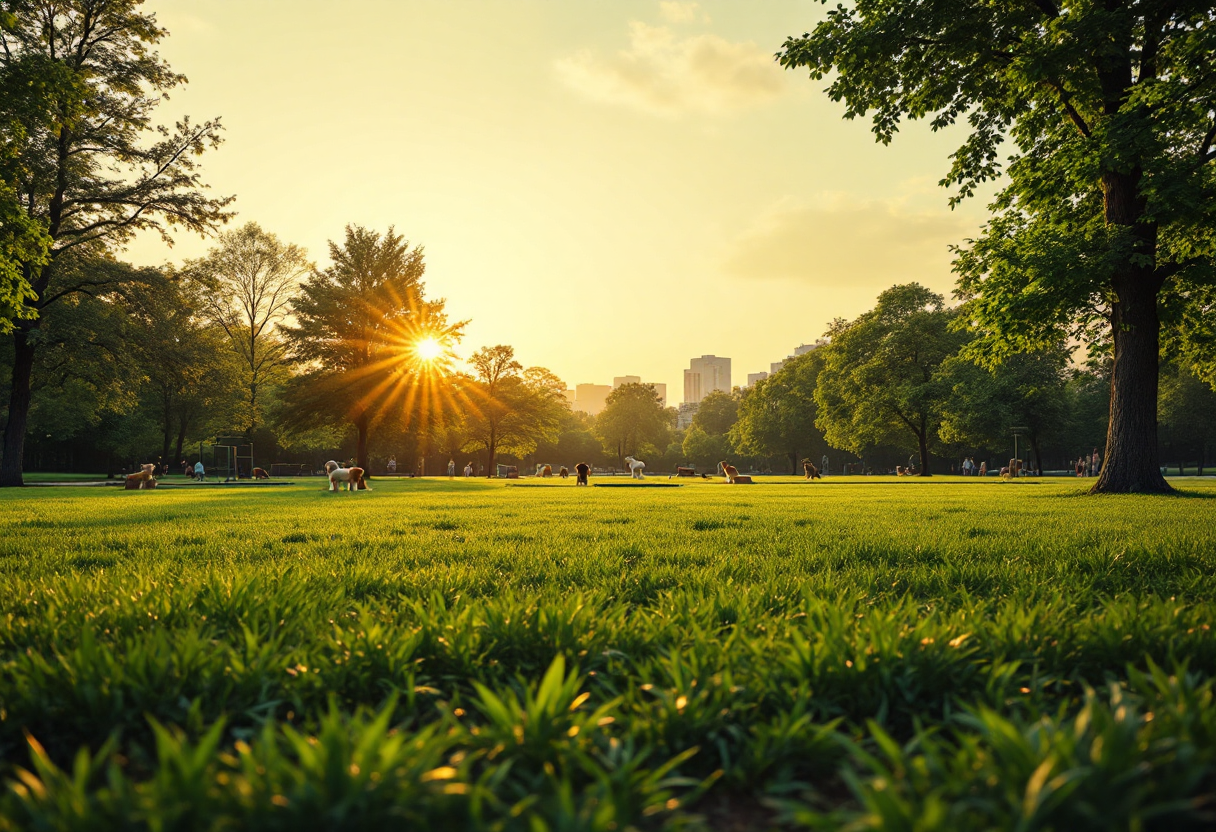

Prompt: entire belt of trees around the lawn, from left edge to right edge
[0,0,1216,491]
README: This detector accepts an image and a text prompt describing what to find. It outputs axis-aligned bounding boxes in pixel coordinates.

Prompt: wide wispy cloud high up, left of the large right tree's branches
[554,21,786,116]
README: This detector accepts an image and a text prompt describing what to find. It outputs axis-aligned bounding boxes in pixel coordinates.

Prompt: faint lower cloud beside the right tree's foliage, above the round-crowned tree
[722,193,978,288]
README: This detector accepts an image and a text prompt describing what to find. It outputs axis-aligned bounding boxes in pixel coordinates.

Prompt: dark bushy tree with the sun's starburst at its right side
[281,225,465,468]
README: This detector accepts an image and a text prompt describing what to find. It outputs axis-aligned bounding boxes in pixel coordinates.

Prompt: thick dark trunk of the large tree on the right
[1090,276,1172,494]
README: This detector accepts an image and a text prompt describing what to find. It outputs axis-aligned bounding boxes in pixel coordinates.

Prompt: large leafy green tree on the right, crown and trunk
[781,0,1216,493]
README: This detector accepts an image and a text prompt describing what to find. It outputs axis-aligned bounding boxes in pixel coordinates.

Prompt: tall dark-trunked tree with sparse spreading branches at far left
[0,0,230,485]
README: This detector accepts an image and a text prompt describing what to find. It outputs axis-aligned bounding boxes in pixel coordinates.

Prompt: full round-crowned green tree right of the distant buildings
[812,283,967,477]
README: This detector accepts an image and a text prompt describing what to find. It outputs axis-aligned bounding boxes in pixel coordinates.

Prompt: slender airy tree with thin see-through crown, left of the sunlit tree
[187,223,311,438]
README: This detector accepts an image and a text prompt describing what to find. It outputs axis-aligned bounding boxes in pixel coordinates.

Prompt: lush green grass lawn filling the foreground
[0,478,1216,831]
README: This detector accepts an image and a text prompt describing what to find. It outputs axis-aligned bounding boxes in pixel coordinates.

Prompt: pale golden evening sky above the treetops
[128,0,984,404]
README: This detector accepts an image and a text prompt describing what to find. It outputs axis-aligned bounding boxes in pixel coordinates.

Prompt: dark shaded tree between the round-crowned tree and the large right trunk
[941,345,1069,474]
